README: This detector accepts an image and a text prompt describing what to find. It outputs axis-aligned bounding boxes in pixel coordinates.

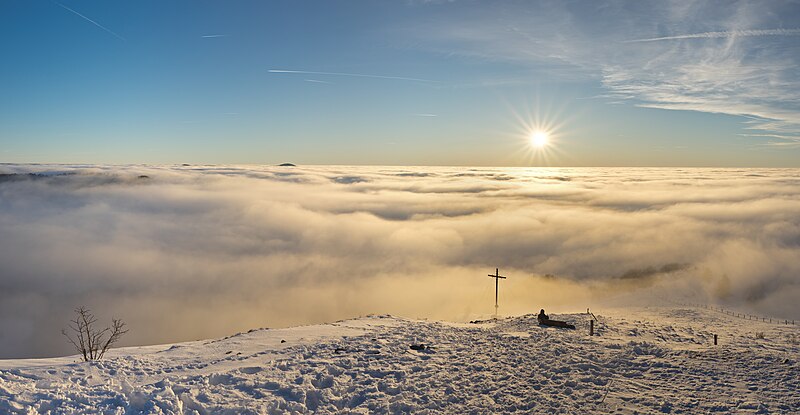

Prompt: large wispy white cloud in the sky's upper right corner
[401,0,800,140]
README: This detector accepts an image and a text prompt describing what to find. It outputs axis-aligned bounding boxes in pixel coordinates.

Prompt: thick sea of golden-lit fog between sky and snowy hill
[0,165,800,357]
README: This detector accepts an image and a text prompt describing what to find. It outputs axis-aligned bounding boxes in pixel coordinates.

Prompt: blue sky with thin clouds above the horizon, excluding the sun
[0,0,800,167]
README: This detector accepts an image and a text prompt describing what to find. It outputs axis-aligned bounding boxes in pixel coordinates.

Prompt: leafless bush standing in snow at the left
[61,306,128,362]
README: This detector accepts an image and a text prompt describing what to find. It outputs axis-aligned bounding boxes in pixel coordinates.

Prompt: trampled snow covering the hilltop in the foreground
[0,305,800,414]
